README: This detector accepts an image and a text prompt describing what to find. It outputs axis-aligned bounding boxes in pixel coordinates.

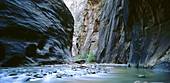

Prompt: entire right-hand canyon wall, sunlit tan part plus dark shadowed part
[63,0,170,70]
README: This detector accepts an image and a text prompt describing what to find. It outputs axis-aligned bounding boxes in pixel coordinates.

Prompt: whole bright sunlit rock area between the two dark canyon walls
[64,0,106,56]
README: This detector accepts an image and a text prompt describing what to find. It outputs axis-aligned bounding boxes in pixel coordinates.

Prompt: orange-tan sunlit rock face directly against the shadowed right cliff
[79,0,104,54]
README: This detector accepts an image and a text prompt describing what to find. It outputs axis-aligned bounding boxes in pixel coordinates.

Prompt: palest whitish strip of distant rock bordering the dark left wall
[64,0,88,56]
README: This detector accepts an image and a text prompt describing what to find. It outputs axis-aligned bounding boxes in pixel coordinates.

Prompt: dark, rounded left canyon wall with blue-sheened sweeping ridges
[0,0,74,66]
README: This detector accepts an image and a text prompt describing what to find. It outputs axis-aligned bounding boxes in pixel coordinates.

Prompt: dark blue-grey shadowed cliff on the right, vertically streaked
[97,0,170,70]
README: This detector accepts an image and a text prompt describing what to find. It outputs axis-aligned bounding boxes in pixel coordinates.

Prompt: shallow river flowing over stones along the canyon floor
[0,64,170,83]
